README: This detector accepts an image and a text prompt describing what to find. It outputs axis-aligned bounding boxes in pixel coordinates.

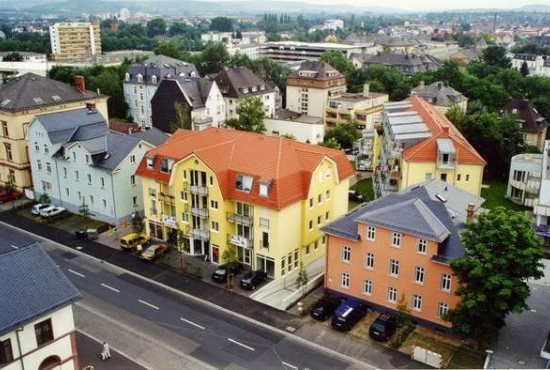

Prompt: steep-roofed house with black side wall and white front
[151,76,226,133]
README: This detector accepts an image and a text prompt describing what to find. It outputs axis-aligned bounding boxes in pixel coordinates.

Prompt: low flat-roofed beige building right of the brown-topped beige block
[325,84,389,129]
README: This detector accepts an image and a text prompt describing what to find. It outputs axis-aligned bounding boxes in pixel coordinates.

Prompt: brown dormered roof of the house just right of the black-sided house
[214,67,273,98]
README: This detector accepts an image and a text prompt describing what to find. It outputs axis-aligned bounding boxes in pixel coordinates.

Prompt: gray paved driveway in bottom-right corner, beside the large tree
[491,260,550,369]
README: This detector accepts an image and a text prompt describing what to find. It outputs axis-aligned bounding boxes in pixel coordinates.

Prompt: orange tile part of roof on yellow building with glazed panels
[403,96,487,165]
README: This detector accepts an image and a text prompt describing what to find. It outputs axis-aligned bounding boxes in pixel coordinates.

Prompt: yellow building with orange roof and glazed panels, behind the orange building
[373,96,486,197]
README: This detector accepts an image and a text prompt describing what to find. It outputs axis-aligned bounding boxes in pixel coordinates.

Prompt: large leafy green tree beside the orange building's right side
[446,207,543,347]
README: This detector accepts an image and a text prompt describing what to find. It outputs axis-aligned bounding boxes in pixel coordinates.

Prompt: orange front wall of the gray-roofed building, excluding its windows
[325,224,459,327]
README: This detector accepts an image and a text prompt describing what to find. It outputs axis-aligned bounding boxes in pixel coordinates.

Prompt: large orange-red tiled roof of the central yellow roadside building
[136,128,354,209]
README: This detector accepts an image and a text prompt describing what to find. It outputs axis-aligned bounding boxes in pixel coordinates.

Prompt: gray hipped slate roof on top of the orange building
[321,180,483,263]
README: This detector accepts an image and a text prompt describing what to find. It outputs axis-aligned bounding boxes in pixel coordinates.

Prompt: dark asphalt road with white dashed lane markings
[0,224,357,369]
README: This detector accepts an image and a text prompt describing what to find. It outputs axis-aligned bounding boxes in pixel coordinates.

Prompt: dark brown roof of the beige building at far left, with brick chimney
[0,73,105,112]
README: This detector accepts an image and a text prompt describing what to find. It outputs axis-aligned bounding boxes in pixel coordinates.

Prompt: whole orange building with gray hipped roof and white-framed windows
[322,180,483,328]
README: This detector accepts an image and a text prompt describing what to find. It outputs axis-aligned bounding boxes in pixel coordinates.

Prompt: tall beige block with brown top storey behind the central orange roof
[286,61,346,118]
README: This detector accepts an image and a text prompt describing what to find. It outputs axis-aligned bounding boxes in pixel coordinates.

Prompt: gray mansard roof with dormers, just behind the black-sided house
[125,55,199,85]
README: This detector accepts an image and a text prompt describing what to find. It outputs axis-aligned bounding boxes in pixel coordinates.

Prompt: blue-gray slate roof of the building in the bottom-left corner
[0,244,82,336]
